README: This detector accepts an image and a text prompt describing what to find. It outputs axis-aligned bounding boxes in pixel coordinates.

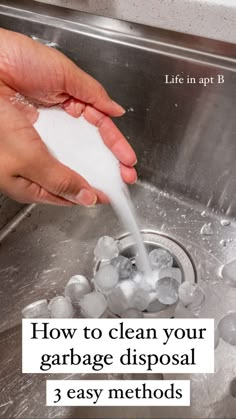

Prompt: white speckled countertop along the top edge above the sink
[36,0,236,43]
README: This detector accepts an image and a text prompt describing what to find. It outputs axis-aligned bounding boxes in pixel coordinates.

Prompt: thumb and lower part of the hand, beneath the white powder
[0,97,97,206]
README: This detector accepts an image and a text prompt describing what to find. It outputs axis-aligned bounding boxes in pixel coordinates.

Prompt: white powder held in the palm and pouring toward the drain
[34,107,151,276]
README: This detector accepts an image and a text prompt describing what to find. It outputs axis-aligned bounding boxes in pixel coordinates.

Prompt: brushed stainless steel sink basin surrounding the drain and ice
[0,0,236,418]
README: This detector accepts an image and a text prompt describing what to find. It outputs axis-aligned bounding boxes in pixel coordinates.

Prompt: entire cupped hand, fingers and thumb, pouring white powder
[0,29,137,206]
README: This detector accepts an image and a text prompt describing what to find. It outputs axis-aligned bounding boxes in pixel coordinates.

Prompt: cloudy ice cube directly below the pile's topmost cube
[94,265,119,294]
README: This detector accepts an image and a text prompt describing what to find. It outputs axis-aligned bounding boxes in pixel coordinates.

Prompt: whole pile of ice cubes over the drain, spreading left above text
[22,236,204,318]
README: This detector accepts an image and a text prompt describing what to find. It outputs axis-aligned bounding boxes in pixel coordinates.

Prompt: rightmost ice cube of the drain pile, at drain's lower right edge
[179,281,205,311]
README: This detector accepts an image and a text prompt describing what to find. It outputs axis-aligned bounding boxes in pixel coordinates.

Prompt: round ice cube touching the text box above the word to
[80,291,107,319]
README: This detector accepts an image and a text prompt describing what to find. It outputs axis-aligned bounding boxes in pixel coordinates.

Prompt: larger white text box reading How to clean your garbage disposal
[22,319,214,373]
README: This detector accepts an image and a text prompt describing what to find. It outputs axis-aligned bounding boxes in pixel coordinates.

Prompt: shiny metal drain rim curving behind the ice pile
[115,231,197,282]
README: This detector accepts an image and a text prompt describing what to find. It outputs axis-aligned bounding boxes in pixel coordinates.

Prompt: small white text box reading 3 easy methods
[46,380,190,406]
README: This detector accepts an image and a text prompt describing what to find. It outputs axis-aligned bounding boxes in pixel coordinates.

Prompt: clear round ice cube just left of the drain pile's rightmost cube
[156,278,179,305]
